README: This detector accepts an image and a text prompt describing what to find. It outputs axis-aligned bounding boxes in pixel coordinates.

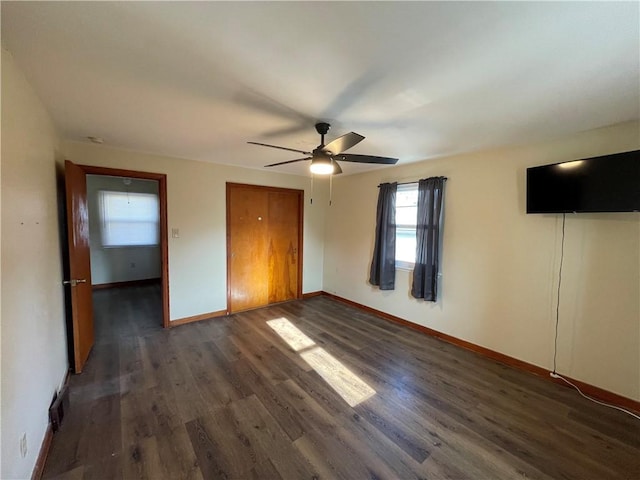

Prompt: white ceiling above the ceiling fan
[2,1,640,174]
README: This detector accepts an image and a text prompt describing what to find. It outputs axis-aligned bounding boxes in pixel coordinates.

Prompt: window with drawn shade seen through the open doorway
[98,190,160,247]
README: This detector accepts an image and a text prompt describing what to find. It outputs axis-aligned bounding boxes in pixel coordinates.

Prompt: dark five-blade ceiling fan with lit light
[247,122,398,175]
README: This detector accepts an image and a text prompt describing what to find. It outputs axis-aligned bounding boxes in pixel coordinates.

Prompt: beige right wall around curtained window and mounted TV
[324,123,640,400]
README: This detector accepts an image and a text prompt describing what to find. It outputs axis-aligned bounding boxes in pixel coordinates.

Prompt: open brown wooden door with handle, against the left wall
[64,161,94,373]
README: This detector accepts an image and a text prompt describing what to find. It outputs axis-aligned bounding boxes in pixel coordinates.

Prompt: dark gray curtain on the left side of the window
[369,182,398,290]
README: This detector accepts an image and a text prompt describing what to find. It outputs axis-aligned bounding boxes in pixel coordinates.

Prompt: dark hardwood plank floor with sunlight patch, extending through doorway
[44,286,640,480]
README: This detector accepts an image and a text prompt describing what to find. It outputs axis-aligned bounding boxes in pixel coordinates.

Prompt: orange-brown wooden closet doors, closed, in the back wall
[227,184,303,313]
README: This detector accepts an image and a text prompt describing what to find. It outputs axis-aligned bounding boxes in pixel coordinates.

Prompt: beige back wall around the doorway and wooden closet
[64,142,327,320]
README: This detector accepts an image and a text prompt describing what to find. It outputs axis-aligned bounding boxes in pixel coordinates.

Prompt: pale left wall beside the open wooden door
[0,49,68,479]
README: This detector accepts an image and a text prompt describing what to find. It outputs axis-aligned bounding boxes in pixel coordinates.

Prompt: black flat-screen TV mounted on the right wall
[527,150,640,213]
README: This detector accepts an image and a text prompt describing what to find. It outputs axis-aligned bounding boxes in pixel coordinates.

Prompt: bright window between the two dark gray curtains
[396,183,418,268]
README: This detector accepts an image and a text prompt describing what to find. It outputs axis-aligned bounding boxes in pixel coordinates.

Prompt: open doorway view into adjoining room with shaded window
[86,174,162,341]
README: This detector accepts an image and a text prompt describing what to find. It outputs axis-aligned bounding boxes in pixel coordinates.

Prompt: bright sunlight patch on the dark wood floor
[267,317,376,407]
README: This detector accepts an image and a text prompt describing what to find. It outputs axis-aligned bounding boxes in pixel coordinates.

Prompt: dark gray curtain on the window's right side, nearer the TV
[411,177,446,302]
